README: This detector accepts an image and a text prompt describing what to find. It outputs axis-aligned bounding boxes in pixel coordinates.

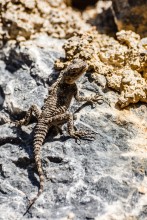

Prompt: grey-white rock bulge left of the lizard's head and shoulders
[0,36,64,114]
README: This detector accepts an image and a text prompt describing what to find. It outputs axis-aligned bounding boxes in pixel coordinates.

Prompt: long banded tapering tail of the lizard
[23,123,48,216]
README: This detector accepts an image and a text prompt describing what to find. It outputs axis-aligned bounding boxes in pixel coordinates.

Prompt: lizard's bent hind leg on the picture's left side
[15,105,41,126]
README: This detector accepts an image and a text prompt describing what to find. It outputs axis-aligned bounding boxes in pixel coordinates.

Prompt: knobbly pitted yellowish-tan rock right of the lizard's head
[56,29,147,108]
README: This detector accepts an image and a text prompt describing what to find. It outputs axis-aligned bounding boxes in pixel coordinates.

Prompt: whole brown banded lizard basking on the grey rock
[15,59,102,215]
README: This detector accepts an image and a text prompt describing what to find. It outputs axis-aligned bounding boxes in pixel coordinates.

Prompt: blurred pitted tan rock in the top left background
[0,0,89,42]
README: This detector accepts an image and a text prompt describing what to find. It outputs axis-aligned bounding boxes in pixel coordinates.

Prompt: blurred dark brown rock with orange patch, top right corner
[112,0,147,37]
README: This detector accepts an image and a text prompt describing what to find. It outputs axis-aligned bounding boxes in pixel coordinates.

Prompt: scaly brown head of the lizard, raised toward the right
[63,59,87,84]
